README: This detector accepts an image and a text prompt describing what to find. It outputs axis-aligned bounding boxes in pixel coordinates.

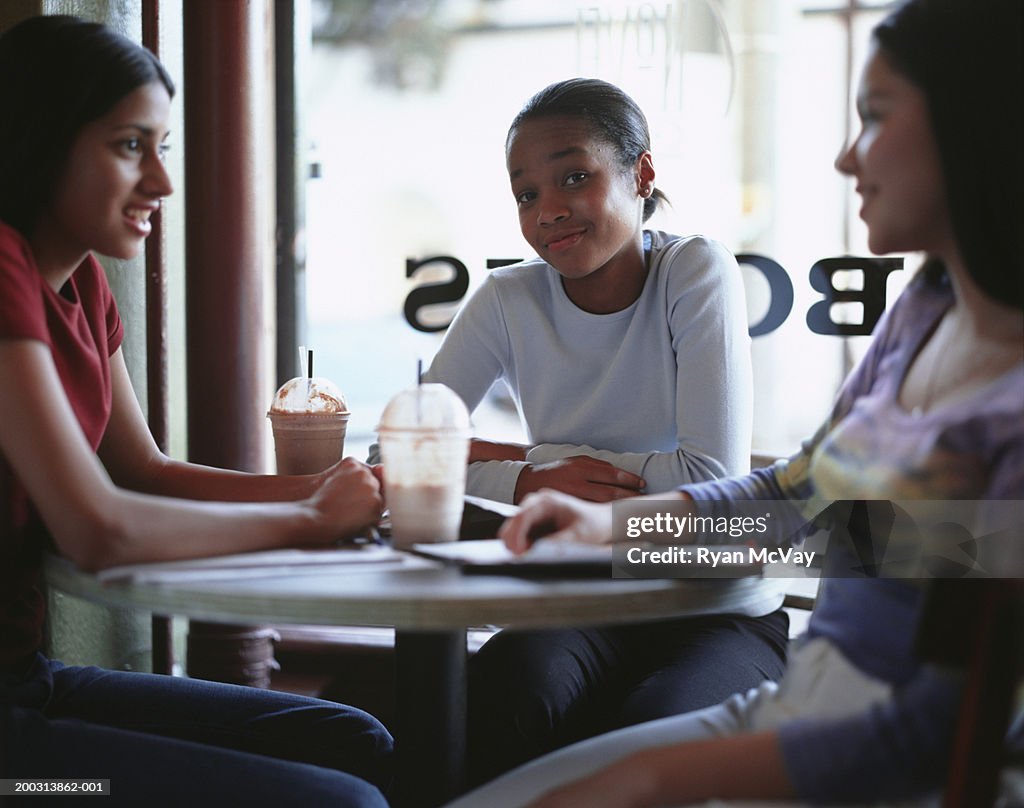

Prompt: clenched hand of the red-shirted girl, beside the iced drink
[309,458,384,541]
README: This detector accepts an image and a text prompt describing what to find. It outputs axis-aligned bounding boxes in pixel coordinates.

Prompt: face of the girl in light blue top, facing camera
[506,117,654,305]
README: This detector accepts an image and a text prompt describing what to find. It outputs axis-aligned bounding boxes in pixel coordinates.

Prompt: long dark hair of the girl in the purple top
[874,0,1024,308]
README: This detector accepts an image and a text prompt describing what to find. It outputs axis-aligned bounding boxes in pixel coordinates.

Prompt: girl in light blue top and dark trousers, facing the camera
[403,79,788,782]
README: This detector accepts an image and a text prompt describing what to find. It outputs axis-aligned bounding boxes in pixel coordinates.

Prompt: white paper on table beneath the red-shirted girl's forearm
[96,545,409,584]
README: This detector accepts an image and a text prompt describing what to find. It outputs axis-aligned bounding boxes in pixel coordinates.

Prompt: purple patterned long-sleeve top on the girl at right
[683,277,1024,802]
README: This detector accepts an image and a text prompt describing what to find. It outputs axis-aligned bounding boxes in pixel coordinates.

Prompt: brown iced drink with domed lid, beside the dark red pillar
[267,376,349,474]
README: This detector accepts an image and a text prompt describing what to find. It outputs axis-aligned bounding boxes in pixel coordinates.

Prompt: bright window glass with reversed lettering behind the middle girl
[307,0,907,457]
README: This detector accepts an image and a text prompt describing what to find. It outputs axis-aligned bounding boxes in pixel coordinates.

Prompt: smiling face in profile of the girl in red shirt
[30,82,174,274]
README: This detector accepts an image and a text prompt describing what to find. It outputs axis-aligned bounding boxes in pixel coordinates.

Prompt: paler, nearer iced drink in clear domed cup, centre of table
[379,384,469,548]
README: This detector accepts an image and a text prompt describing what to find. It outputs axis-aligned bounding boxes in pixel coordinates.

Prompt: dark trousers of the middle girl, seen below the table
[467,609,790,786]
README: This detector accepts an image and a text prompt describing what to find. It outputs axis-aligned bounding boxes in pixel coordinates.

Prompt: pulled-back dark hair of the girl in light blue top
[505,79,669,221]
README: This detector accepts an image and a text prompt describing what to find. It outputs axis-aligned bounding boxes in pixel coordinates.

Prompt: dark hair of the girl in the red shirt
[0,15,174,237]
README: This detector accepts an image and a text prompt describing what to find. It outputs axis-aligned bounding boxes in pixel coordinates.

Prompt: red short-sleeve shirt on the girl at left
[0,221,124,664]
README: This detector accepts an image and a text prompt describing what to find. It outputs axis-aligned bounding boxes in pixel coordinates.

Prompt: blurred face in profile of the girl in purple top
[836,48,952,255]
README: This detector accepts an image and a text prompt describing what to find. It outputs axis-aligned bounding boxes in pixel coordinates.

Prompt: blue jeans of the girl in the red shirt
[0,655,392,808]
